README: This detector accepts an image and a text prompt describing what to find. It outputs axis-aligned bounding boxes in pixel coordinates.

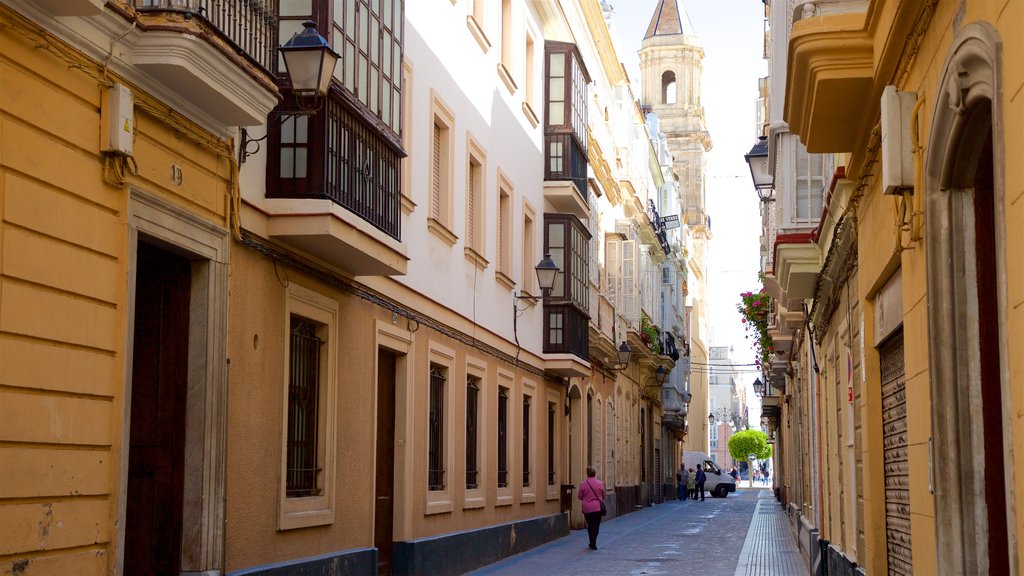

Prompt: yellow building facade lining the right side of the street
[773,0,1024,574]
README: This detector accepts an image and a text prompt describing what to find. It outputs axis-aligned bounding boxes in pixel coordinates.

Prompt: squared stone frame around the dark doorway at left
[115,189,230,576]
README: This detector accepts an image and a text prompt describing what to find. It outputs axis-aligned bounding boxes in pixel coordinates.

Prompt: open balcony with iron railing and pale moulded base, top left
[130,0,280,128]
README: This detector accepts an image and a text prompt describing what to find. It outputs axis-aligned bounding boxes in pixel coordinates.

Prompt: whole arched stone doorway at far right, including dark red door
[925,23,1017,574]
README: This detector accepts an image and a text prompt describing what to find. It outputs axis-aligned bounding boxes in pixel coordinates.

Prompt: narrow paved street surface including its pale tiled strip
[470,489,808,576]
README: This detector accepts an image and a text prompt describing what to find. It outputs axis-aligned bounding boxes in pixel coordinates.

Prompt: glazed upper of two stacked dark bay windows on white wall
[544,41,590,199]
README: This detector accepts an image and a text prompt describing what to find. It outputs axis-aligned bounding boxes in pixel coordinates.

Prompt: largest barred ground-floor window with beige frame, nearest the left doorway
[278,285,338,530]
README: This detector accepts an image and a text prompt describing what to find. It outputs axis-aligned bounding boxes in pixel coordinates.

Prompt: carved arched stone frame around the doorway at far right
[925,23,1017,574]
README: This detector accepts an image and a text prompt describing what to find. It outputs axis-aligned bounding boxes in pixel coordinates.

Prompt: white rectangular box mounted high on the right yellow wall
[882,86,918,194]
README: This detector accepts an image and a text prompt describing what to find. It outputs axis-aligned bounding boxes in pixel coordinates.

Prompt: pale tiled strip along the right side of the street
[735,490,808,576]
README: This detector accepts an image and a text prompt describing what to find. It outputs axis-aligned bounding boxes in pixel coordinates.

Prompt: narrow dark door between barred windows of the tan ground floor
[374,349,395,576]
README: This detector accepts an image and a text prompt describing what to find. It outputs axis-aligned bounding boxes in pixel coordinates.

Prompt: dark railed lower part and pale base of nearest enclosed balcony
[263,96,409,276]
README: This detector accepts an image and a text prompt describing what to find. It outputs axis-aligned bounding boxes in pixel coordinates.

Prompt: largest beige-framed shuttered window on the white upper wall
[427,94,456,246]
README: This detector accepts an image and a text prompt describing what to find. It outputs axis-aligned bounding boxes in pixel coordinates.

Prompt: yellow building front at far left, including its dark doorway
[0,2,266,574]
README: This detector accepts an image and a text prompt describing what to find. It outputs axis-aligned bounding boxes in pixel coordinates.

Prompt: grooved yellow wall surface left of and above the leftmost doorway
[0,3,229,575]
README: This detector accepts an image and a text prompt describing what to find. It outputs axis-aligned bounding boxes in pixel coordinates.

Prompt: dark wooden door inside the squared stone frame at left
[124,242,191,576]
